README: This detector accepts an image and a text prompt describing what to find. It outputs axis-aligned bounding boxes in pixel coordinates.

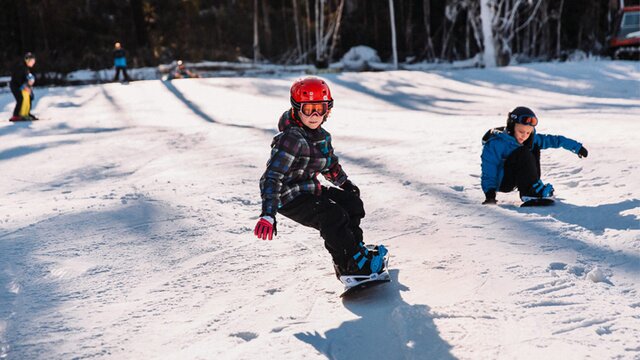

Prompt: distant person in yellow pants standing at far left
[9,52,38,121]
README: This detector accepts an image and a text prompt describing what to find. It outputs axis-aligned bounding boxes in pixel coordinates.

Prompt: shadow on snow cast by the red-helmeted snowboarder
[294,269,455,360]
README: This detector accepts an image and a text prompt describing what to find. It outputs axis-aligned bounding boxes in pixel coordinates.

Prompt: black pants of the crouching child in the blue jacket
[500,146,540,194]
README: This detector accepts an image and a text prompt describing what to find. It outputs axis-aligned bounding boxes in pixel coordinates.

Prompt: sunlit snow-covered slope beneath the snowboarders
[0,61,640,359]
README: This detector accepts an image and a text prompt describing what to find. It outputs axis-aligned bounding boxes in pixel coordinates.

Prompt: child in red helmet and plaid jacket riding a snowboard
[254,77,387,276]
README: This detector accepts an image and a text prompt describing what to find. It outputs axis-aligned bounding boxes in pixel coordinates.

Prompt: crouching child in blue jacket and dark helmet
[481,106,588,204]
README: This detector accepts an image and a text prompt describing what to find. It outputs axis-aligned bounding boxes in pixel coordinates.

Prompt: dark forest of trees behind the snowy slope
[0,0,636,74]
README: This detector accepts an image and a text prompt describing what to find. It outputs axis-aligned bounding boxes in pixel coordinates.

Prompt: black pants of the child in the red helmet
[278,187,365,265]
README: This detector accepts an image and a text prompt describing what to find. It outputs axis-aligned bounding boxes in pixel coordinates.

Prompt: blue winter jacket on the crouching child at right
[481,129,582,193]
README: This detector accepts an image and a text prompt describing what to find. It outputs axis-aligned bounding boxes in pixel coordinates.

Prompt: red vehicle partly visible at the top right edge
[609,6,640,60]
